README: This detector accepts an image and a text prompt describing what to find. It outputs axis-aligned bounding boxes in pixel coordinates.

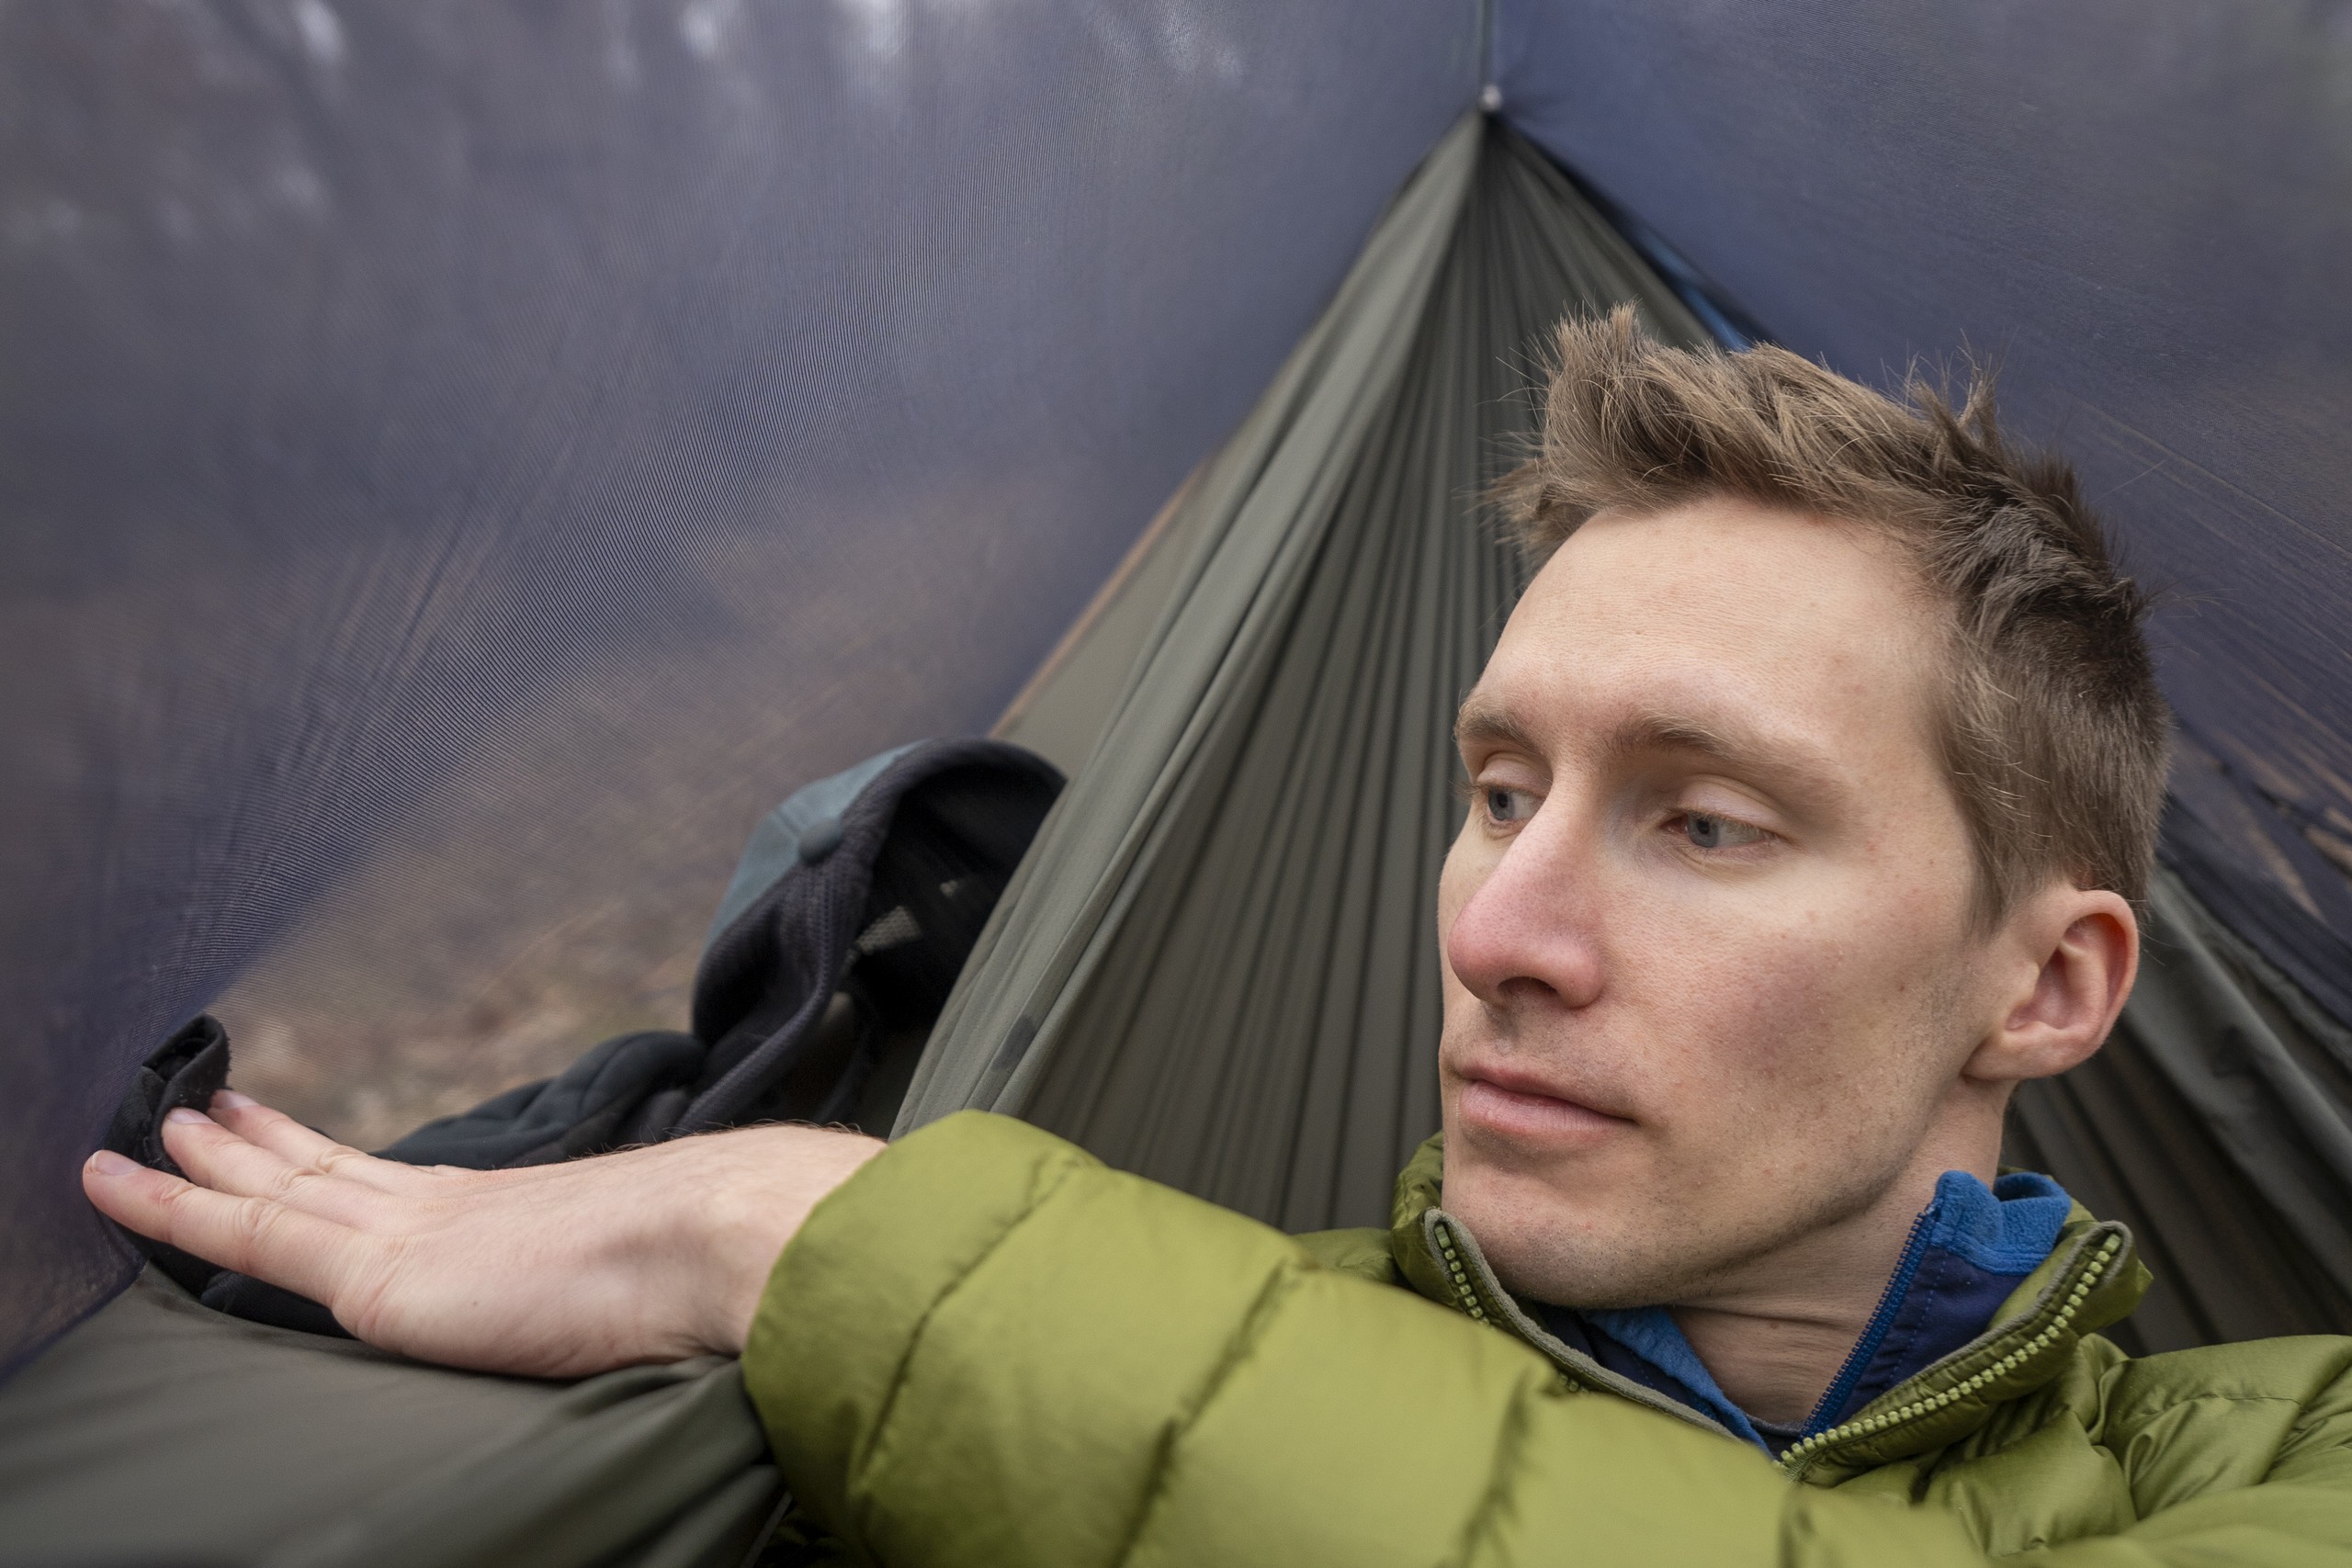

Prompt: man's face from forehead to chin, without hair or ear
[1437,501,1985,1307]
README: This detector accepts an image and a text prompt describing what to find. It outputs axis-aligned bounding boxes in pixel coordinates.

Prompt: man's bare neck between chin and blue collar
[1670,1149,1992,1427]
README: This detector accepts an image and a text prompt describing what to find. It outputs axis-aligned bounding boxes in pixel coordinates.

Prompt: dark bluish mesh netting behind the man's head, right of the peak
[1496,0,2352,982]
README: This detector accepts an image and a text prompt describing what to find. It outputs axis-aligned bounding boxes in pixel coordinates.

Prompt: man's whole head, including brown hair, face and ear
[1440,312,2166,1304]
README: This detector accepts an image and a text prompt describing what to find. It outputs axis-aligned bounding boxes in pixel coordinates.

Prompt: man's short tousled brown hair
[1498,308,2171,924]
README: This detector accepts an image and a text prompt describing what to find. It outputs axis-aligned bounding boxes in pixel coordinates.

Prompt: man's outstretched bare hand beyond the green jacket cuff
[83,1090,882,1378]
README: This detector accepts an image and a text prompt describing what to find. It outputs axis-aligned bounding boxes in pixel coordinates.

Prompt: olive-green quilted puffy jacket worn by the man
[743,1112,2352,1568]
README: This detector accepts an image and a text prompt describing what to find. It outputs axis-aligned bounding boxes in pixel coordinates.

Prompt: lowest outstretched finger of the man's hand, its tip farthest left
[83,1149,357,1307]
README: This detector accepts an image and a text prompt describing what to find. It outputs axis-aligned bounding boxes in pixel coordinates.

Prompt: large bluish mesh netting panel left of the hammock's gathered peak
[0,0,1477,1363]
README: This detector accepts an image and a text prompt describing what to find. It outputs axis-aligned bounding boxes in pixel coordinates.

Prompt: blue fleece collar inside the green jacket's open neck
[1543,1170,2072,1453]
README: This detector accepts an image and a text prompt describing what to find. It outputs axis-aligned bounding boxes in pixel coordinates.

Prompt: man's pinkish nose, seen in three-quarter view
[1446,802,1601,1009]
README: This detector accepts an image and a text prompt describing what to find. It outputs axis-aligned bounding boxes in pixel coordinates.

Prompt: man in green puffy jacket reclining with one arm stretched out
[87,315,2352,1563]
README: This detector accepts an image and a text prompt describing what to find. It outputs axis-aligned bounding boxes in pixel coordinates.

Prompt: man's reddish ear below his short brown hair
[1962,884,2141,1084]
